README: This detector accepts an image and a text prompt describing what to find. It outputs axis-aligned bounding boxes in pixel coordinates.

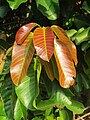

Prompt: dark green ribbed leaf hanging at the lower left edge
[1,75,15,119]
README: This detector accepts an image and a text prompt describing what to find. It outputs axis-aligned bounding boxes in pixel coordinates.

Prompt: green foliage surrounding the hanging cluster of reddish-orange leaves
[0,0,90,120]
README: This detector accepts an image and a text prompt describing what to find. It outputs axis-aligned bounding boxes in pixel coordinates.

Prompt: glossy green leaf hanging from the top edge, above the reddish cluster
[36,0,60,20]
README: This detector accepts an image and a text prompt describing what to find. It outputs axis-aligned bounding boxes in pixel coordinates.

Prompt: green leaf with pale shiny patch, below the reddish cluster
[37,81,72,110]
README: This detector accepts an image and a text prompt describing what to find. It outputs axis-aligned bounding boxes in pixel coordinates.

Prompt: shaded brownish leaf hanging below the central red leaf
[39,59,54,81]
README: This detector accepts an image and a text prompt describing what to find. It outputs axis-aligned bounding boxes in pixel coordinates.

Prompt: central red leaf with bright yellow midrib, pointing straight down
[34,27,55,62]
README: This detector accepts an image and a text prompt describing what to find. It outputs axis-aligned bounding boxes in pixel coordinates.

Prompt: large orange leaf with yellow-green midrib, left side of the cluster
[10,34,34,85]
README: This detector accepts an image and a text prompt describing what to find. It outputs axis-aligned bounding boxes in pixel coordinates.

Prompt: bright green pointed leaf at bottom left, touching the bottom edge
[14,99,27,120]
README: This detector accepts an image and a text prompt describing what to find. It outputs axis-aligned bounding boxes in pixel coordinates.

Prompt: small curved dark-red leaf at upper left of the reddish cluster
[15,23,38,45]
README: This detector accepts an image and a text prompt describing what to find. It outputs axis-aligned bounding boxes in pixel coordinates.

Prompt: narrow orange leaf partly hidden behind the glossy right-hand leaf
[51,25,78,65]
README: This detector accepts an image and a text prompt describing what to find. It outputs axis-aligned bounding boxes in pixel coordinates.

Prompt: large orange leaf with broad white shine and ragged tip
[54,40,76,88]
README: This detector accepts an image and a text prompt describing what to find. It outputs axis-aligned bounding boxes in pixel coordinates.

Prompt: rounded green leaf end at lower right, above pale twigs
[66,100,84,114]
